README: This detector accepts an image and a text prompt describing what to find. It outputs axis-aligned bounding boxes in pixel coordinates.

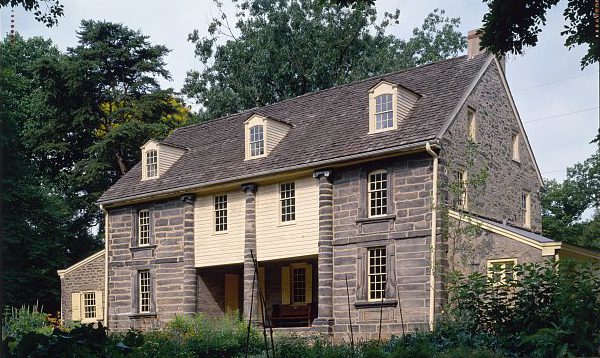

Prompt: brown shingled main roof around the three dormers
[98,55,489,204]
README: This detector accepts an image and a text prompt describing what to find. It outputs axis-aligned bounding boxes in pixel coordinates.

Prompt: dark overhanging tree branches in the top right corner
[481,0,600,68]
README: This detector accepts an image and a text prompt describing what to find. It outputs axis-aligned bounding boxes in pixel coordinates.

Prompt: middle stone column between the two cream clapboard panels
[242,184,259,319]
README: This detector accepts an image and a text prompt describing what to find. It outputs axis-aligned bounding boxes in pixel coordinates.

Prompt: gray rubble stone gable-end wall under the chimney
[440,63,542,232]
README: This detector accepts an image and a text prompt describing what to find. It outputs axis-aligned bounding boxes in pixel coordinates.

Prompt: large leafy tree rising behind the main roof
[183,0,465,118]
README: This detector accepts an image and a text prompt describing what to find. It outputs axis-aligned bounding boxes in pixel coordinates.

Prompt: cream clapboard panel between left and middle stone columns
[194,190,245,267]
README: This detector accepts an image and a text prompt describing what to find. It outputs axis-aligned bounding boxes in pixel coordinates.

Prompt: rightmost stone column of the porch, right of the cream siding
[313,170,334,334]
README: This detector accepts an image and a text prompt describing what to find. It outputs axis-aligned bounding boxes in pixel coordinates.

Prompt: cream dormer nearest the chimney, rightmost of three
[368,81,419,134]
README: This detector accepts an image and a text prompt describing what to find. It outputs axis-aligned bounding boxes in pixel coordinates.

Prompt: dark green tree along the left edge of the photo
[0,35,99,311]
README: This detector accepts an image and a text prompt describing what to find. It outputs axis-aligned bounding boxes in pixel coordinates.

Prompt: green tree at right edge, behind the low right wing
[542,149,600,249]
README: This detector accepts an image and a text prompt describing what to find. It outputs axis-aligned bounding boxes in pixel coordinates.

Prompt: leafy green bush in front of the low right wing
[445,260,600,357]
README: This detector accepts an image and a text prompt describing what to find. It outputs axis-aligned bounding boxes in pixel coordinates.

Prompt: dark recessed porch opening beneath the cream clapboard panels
[196,255,318,328]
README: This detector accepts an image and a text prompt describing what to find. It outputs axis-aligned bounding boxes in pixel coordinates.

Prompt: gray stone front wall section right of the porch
[333,153,440,339]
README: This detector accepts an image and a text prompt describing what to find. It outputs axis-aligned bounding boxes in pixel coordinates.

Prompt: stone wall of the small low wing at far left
[60,255,105,322]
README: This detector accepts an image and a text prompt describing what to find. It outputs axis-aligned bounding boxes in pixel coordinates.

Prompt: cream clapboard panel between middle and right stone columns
[256,177,319,261]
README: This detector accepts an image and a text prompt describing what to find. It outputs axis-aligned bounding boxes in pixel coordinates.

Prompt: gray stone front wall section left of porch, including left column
[108,196,197,331]
